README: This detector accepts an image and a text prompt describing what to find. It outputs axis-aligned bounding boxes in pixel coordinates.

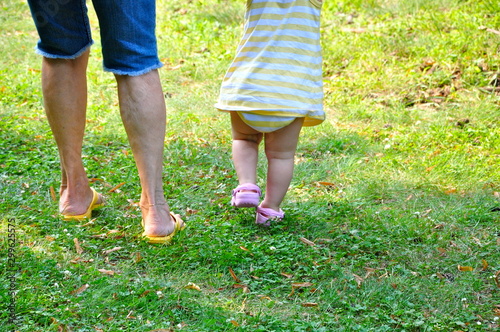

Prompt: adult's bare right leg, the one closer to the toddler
[116,70,174,236]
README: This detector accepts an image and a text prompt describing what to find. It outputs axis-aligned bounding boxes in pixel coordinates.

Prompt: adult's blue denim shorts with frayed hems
[28,0,162,76]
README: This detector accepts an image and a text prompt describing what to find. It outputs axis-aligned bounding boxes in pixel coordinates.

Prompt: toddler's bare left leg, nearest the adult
[230,112,263,184]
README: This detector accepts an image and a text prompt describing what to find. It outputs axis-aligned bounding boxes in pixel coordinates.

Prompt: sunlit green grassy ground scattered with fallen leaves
[0,0,500,332]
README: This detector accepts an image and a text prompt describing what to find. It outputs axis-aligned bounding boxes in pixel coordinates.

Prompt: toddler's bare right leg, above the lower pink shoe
[260,118,304,211]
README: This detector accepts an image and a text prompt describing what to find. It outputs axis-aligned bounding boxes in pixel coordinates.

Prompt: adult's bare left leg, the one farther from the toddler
[42,51,102,215]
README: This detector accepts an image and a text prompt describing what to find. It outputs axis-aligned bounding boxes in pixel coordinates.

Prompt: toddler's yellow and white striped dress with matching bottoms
[215,0,325,132]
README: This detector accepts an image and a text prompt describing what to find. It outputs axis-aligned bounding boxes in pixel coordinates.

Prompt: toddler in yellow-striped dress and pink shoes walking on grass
[215,0,325,226]
